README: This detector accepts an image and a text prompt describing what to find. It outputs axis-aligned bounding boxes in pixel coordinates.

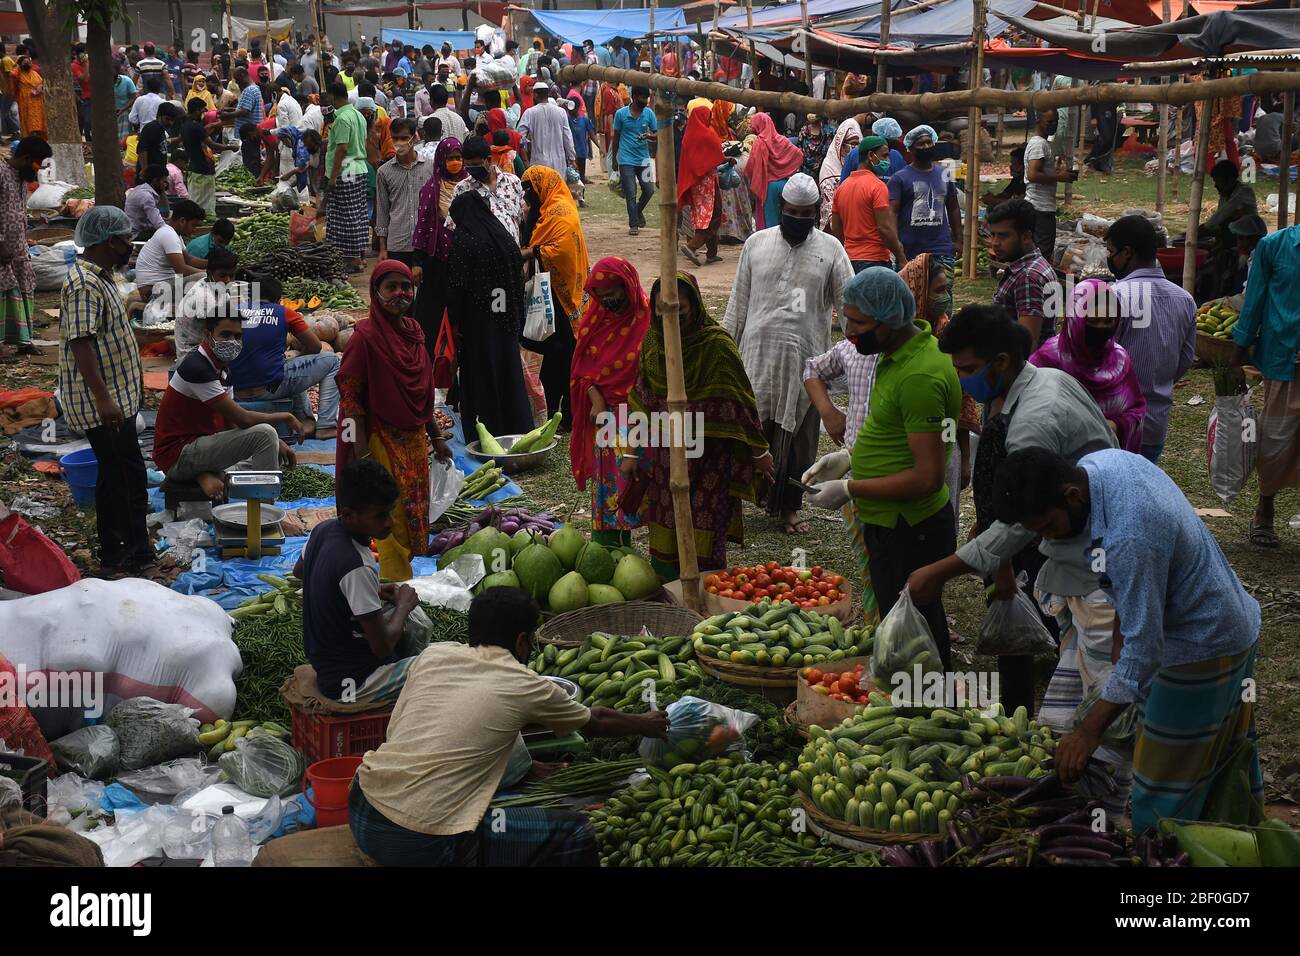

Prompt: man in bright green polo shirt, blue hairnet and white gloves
[803,265,962,670]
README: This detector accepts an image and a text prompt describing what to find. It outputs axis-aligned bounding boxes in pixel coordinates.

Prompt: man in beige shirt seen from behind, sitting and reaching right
[341,587,668,866]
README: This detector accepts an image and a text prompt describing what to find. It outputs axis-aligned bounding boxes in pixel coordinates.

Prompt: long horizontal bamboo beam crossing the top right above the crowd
[560,61,1300,118]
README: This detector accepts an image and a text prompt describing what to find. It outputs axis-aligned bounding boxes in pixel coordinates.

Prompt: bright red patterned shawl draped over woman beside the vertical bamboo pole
[569,256,650,488]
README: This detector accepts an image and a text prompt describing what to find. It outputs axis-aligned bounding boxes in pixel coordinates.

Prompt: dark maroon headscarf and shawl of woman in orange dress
[337,259,433,466]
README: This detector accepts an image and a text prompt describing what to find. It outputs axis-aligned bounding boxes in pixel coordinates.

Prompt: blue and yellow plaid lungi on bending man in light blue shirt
[1132,645,1264,832]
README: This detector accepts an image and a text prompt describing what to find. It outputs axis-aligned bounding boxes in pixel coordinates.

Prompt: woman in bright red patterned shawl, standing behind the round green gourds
[569,256,650,546]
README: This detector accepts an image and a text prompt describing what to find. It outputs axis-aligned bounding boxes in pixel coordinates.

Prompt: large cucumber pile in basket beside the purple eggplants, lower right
[790,695,1056,834]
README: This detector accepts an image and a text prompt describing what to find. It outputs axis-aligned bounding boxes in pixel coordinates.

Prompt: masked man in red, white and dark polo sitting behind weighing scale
[153,311,304,501]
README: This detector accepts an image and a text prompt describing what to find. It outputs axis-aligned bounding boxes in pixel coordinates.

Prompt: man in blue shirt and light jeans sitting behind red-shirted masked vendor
[230,276,339,440]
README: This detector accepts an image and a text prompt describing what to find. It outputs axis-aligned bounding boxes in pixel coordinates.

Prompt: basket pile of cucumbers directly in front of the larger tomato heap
[690,598,872,667]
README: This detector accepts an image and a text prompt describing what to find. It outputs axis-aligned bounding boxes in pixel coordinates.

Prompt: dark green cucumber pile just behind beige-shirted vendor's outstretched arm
[528,633,703,709]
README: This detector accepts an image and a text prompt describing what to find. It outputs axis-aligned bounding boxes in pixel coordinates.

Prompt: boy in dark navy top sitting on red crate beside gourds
[294,458,419,704]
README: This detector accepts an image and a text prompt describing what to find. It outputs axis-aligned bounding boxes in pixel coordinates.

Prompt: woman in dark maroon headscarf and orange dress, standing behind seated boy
[335,259,451,581]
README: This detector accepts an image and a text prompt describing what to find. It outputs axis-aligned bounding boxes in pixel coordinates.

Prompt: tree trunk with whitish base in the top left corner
[22,0,90,186]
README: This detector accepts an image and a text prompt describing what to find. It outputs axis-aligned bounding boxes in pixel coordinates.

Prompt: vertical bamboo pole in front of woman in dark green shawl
[655,96,705,614]
